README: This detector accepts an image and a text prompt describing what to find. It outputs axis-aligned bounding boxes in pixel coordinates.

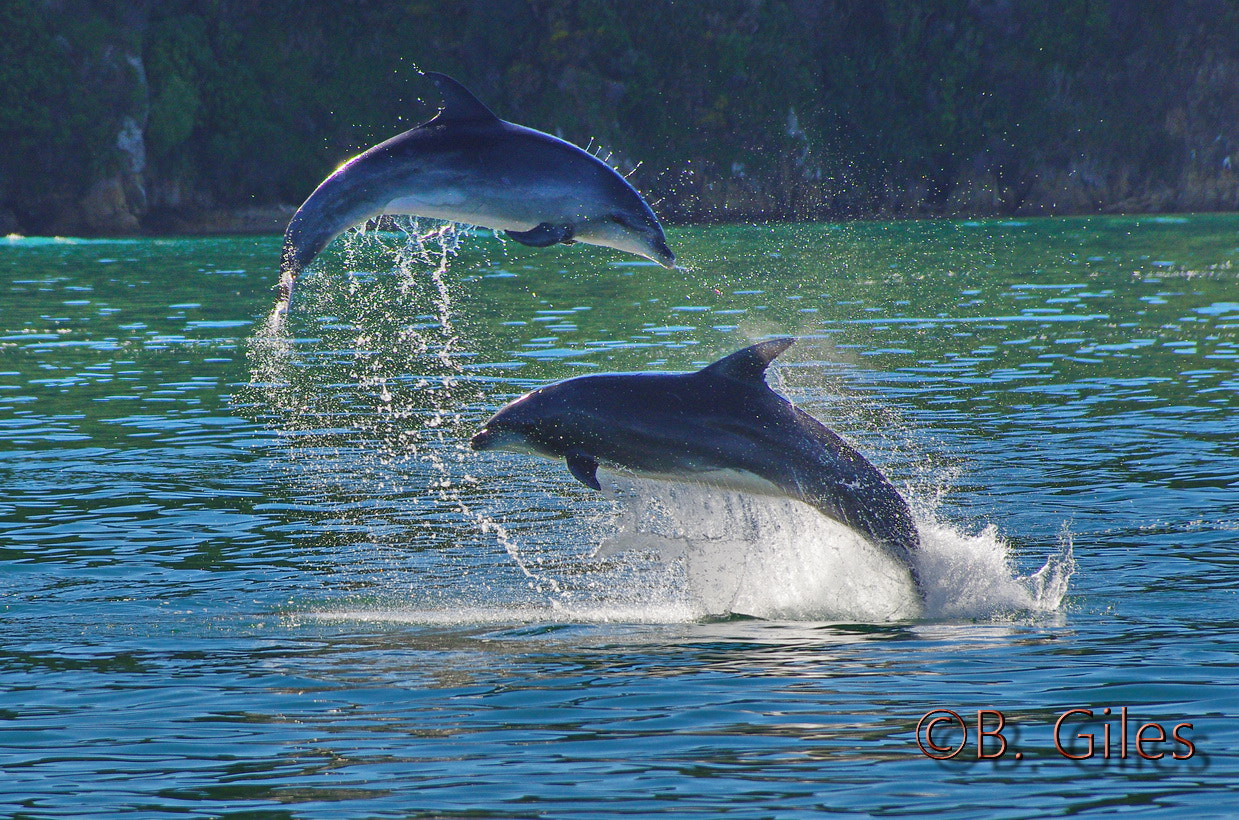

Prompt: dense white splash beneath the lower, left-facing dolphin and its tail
[574,477,1074,622]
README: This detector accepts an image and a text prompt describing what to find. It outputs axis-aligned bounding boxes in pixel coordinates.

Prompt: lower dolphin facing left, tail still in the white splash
[470,338,924,600]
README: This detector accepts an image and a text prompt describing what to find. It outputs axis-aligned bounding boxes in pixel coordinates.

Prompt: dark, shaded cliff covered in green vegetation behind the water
[0,0,1239,232]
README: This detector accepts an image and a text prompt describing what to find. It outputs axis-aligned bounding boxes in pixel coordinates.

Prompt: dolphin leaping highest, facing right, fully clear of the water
[279,73,675,308]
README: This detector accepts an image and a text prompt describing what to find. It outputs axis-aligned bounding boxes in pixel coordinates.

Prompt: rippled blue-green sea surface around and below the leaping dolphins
[0,214,1239,818]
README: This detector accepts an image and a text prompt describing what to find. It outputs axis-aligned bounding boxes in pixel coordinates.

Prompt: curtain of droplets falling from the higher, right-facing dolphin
[248,218,560,593]
